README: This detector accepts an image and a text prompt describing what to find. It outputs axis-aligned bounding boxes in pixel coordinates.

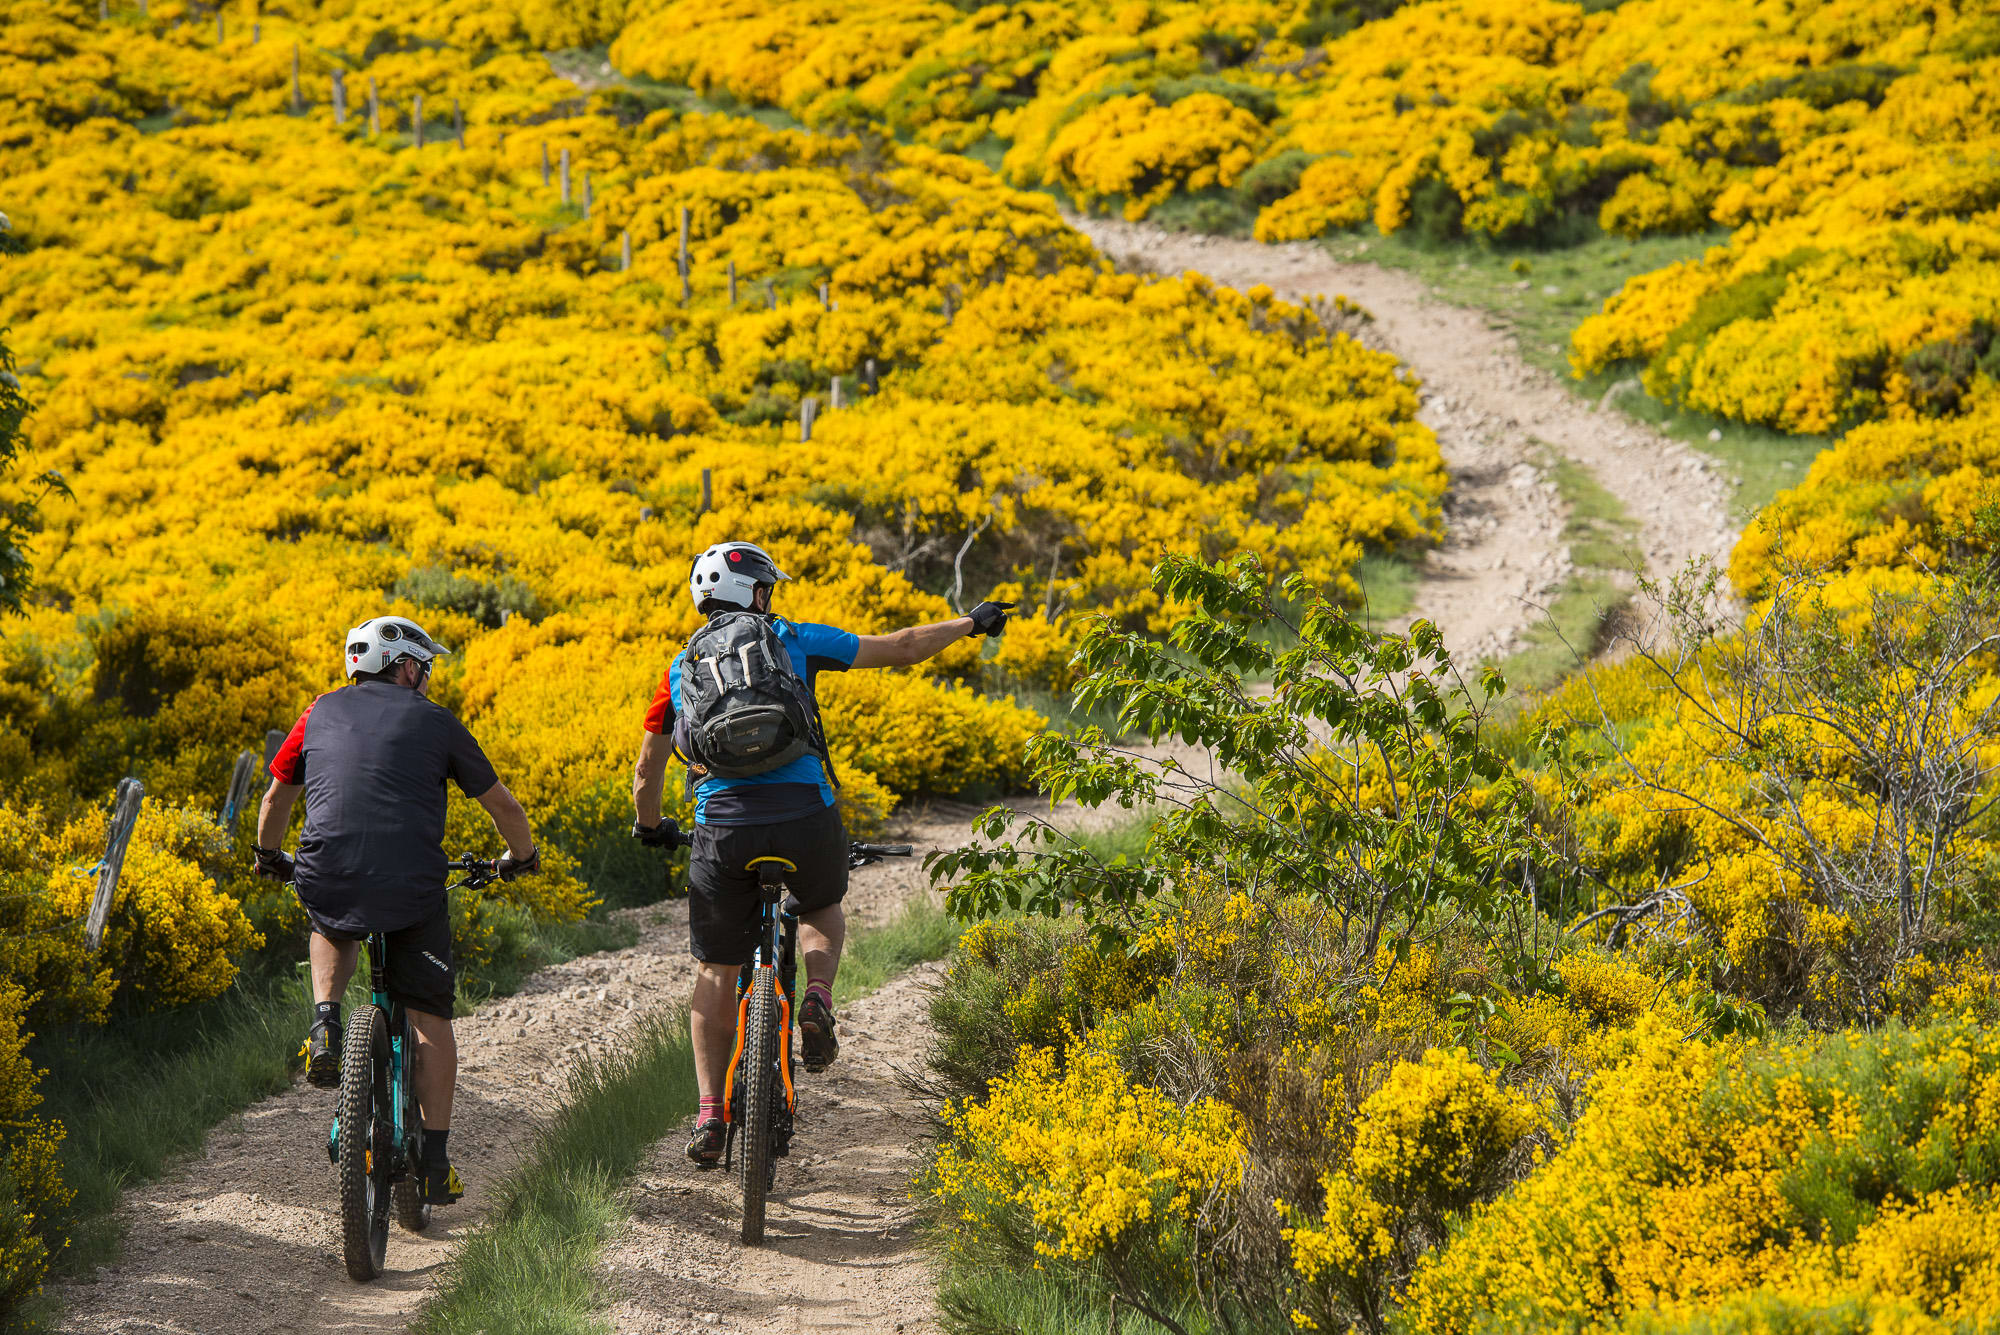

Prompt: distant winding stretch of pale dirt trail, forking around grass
[1070,216,1736,660]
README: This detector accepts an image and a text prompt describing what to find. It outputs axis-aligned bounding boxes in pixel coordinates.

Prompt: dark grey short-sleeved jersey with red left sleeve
[270,681,500,931]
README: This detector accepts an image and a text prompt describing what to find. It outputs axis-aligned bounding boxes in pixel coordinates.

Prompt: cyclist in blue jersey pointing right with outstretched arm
[632,542,1012,1167]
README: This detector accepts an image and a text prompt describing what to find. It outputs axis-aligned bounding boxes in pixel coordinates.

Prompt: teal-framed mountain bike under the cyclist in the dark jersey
[326,857,500,1281]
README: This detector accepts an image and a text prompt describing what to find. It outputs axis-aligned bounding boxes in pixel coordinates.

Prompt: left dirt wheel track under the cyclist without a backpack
[58,803,978,1335]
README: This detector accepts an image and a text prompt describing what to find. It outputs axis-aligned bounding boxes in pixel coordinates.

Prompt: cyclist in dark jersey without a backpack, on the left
[256,616,542,1205]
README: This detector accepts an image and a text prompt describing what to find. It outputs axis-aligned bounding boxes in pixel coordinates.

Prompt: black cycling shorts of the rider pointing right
[688,807,848,965]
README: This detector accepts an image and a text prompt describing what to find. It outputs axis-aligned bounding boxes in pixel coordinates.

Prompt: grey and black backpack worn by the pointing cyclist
[680,612,832,779]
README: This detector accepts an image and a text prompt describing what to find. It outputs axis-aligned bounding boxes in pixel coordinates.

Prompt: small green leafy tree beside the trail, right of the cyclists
[928,556,1546,991]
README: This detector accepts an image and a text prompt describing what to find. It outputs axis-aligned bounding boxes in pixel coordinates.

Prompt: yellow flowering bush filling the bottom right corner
[1404,1021,2000,1331]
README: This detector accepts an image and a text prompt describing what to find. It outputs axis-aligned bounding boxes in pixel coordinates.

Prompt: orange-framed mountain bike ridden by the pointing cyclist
[684,835,910,1247]
